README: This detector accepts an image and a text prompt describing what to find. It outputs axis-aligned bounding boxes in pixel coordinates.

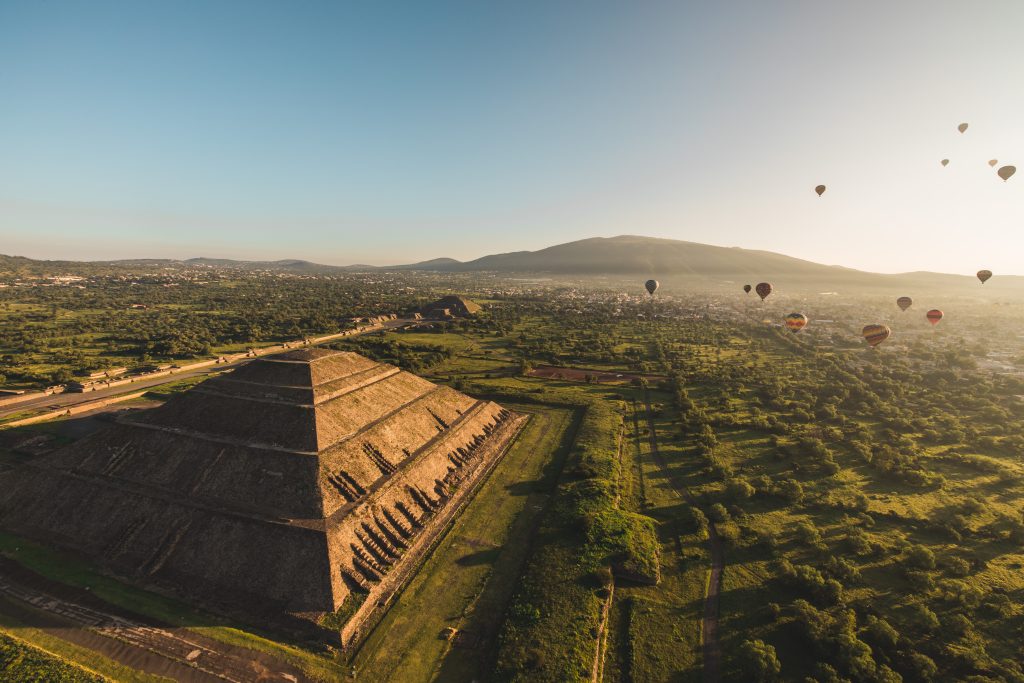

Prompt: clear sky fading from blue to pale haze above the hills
[0,0,1024,272]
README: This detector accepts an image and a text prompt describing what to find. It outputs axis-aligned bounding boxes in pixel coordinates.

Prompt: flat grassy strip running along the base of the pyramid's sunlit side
[352,403,577,683]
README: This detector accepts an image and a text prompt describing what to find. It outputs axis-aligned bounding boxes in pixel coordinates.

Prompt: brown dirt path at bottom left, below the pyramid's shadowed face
[0,560,310,683]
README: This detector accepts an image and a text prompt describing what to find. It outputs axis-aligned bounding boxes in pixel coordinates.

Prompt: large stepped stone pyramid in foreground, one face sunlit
[0,348,524,639]
